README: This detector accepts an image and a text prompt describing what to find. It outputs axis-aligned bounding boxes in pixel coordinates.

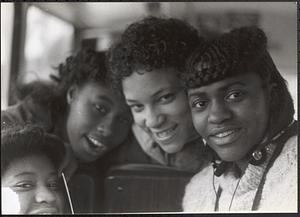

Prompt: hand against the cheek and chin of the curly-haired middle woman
[132,123,167,165]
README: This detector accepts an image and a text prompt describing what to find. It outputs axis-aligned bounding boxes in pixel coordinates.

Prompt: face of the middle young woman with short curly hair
[122,68,197,153]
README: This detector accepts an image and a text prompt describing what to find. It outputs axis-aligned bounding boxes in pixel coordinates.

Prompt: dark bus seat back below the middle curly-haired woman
[103,164,193,213]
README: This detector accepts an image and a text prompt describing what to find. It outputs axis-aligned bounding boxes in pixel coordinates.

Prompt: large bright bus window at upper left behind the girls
[19,6,74,83]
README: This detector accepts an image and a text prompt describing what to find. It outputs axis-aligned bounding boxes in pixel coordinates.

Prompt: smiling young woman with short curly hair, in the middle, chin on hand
[108,17,209,172]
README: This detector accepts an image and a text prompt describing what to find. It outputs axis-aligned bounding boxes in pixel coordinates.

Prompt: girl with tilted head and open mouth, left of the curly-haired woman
[1,50,131,176]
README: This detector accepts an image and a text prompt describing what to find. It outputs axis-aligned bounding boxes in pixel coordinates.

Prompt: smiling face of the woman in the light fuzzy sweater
[188,73,270,161]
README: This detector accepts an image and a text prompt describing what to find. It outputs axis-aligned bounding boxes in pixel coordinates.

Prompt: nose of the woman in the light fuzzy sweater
[208,100,232,124]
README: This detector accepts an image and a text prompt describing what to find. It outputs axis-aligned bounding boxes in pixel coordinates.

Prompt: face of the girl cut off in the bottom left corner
[1,155,64,214]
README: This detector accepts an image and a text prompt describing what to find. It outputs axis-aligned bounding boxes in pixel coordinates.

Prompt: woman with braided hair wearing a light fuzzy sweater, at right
[182,27,297,212]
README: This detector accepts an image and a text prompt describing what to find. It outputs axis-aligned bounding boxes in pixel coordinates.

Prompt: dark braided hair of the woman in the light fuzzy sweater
[181,26,294,137]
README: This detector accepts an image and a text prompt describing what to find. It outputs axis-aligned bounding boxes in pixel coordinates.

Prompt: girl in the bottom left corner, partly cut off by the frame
[1,126,67,215]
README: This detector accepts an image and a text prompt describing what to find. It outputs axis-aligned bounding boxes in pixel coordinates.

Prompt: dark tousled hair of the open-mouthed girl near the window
[18,49,108,117]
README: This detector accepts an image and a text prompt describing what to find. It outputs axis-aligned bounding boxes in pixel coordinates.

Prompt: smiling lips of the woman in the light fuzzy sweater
[209,128,242,145]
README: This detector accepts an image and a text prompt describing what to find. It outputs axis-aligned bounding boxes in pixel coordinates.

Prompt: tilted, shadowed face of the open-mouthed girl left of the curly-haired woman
[66,81,132,162]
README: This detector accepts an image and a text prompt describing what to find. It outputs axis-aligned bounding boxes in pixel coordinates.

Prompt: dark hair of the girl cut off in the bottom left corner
[1,125,65,176]
